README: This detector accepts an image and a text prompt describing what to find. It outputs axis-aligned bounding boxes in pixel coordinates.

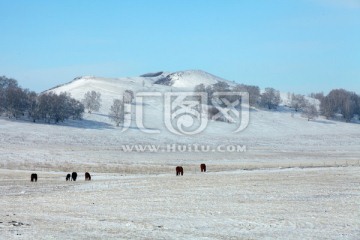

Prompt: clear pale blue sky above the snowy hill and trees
[0,0,360,94]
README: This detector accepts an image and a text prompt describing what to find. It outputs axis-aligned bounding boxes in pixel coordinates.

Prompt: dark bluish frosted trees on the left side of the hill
[0,76,134,126]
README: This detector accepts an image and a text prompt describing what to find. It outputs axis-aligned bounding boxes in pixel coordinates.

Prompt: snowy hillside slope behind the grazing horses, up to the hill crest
[0,68,360,172]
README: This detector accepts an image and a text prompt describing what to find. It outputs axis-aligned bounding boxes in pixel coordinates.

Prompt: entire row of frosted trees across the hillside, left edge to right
[0,76,360,126]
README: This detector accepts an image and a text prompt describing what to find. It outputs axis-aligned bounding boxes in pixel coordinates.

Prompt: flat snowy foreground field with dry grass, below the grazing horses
[0,167,360,239]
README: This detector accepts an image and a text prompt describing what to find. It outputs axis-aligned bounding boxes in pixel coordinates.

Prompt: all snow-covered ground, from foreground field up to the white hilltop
[0,71,360,239]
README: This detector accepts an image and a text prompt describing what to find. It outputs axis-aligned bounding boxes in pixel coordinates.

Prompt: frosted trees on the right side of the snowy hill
[194,82,360,122]
